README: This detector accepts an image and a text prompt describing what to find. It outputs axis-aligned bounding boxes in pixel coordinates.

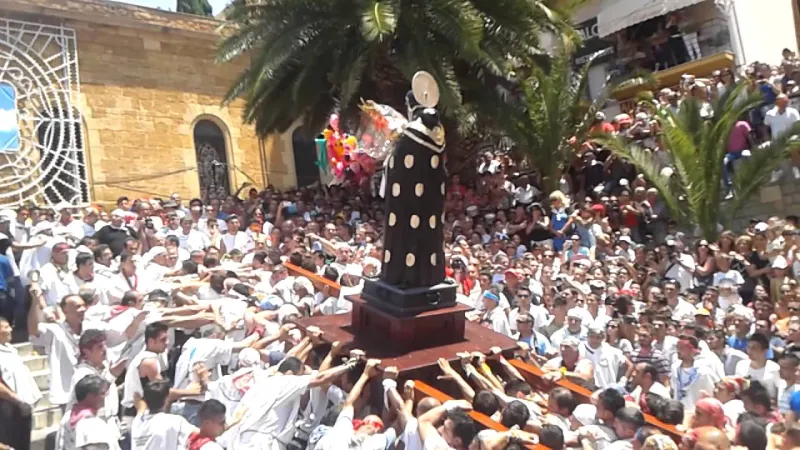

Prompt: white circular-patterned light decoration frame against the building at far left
[0,18,90,207]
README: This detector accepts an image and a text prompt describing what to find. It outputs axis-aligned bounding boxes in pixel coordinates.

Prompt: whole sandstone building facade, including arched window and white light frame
[0,0,297,206]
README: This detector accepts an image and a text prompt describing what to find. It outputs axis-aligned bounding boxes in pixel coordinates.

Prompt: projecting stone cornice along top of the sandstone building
[0,0,224,40]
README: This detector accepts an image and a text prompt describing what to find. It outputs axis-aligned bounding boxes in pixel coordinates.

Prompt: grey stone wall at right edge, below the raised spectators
[732,178,800,231]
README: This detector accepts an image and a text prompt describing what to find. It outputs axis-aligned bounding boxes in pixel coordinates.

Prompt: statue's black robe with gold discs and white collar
[380,108,446,289]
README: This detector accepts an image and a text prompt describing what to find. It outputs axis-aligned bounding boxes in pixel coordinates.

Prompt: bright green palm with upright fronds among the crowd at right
[597,83,800,240]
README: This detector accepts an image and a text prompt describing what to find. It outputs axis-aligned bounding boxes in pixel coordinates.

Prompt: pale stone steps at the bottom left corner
[14,342,61,450]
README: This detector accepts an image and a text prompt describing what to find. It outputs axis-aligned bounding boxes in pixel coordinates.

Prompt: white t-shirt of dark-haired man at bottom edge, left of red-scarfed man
[131,411,197,450]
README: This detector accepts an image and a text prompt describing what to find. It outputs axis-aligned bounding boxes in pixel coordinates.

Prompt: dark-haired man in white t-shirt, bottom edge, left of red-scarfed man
[131,380,197,450]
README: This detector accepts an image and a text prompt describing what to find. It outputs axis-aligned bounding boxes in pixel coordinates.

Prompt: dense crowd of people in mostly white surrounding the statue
[0,51,800,450]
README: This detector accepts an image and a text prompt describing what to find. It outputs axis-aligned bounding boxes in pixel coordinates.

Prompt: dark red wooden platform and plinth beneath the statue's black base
[297,296,516,380]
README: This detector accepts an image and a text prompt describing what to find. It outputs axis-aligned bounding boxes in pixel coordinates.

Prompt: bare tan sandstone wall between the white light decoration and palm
[0,0,296,205]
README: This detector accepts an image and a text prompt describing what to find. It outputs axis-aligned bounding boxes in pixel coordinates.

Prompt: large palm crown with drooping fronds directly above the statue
[218,0,582,141]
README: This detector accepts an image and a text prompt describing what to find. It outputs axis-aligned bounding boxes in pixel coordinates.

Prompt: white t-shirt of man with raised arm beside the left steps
[31,322,80,405]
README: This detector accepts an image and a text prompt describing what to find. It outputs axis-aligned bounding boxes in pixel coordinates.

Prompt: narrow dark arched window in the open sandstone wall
[194,119,230,201]
